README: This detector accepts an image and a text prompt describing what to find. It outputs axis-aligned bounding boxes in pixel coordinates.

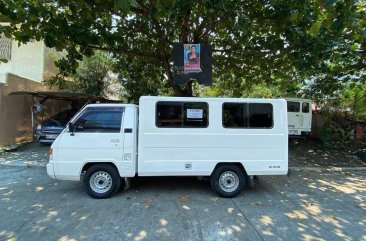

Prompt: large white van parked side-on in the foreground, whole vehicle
[47,96,288,198]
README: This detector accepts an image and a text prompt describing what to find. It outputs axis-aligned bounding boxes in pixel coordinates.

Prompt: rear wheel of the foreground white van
[211,164,246,198]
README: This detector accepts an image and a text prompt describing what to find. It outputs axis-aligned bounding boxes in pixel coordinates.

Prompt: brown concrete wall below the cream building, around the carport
[0,74,70,146]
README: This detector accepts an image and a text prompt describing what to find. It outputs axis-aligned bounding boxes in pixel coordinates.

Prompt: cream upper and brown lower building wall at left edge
[0,31,70,146]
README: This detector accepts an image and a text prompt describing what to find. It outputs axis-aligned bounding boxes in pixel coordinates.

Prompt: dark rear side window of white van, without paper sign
[222,103,273,128]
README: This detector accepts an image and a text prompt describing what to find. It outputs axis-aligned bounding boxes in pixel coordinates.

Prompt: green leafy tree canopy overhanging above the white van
[0,0,366,99]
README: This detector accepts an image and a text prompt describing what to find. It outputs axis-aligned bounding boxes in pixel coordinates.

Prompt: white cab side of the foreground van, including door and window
[56,106,125,177]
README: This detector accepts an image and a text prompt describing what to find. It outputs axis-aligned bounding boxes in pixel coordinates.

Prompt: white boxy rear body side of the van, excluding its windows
[138,97,288,176]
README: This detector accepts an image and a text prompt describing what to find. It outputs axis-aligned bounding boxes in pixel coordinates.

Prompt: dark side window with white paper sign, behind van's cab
[156,101,208,128]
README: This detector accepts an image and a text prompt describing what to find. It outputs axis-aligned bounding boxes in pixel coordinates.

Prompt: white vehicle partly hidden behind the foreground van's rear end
[286,98,312,136]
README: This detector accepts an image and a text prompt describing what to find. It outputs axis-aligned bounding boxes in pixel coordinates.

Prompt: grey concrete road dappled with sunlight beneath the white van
[0,166,366,241]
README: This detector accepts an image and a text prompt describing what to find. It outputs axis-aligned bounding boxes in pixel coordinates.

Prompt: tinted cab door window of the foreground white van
[74,107,123,133]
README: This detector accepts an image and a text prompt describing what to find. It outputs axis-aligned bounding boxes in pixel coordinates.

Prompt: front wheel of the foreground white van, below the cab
[84,164,121,199]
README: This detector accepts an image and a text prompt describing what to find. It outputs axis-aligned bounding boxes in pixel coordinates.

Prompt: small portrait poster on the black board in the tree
[184,44,202,73]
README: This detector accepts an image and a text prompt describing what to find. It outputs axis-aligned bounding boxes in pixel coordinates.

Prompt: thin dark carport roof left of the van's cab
[9,90,119,102]
